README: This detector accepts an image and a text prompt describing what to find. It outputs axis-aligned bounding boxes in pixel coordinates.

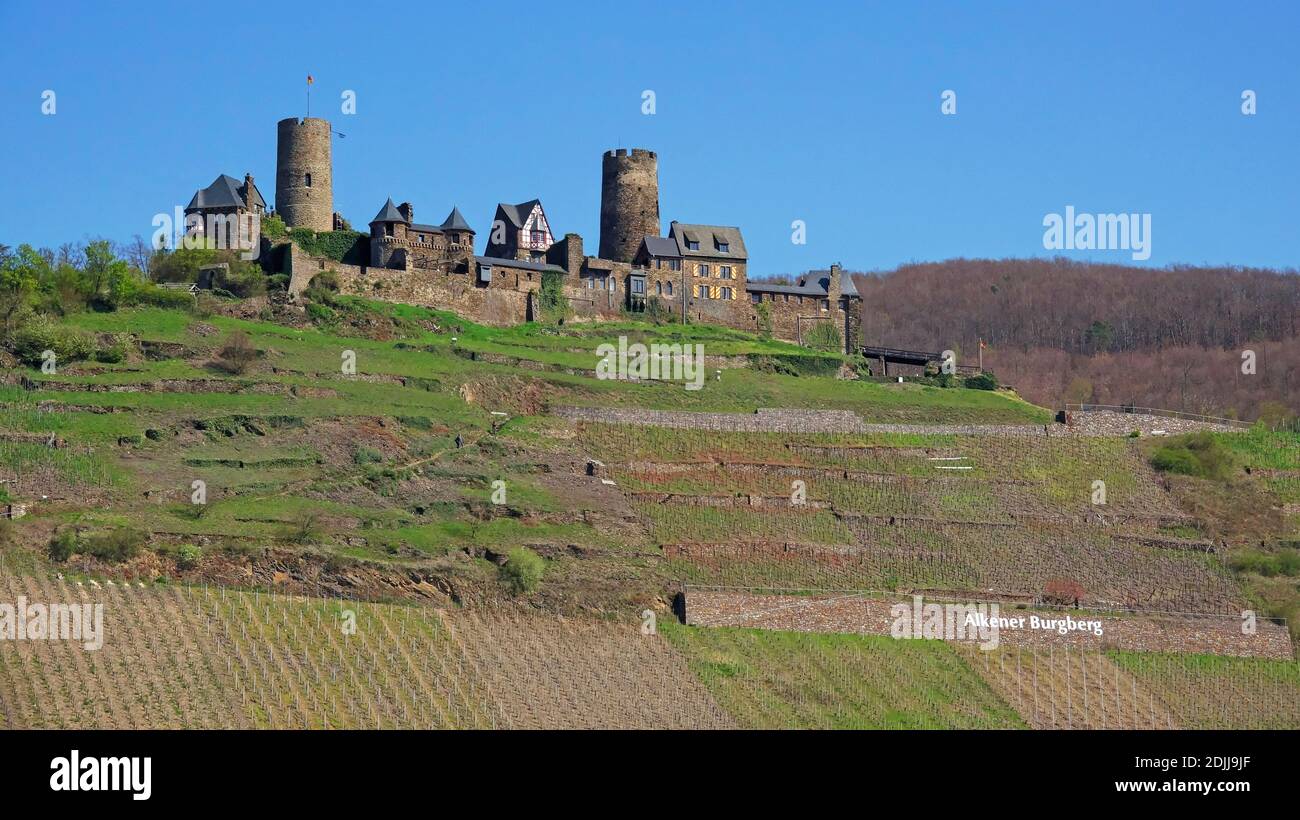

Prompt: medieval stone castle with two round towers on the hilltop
[186,117,861,351]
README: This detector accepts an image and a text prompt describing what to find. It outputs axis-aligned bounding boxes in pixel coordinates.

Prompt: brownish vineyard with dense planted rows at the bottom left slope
[0,574,731,729]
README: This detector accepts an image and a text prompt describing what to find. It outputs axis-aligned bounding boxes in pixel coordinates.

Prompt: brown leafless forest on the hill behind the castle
[854,259,1300,420]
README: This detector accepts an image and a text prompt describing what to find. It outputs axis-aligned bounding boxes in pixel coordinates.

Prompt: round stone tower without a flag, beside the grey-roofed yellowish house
[599,148,659,263]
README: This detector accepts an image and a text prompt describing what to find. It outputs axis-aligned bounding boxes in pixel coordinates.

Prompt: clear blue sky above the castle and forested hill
[0,0,1300,275]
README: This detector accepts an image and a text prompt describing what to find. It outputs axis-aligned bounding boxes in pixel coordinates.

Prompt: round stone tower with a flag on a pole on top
[276,117,334,231]
